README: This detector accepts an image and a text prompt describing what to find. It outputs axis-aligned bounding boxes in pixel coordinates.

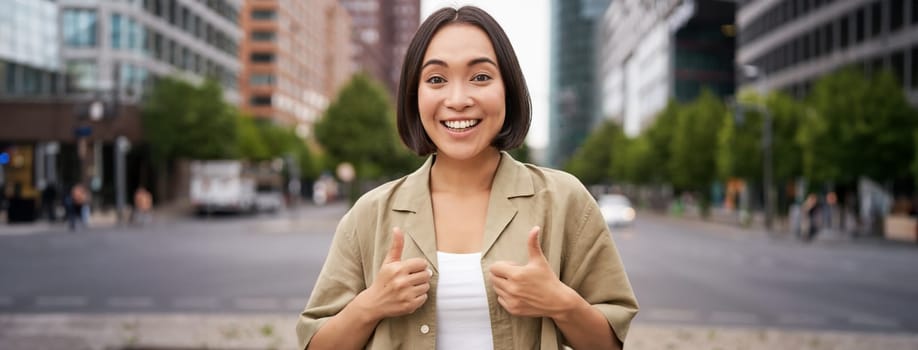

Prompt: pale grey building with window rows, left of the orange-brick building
[57,0,242,102]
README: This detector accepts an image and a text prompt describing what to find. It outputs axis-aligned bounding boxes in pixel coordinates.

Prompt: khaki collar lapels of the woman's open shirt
[392,151,535,268]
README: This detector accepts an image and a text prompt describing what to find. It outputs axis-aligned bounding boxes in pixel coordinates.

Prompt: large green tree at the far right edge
[798,68,918,184]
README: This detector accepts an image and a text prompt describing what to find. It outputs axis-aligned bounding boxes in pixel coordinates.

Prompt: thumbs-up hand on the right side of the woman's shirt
[489,226,579,317]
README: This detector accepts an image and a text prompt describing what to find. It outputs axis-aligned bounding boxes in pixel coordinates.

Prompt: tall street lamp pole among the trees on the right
[736,64,774,231]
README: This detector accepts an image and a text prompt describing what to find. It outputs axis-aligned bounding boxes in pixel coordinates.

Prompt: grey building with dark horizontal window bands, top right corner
[736,0,918,105]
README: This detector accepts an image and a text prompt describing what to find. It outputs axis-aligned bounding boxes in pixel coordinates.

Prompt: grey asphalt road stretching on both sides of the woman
[0,205,918,348]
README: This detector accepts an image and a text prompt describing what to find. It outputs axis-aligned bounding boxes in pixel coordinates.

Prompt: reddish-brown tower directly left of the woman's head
[340,0,421,96]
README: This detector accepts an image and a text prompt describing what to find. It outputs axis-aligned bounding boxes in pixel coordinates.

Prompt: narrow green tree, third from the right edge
[669,90,726,215]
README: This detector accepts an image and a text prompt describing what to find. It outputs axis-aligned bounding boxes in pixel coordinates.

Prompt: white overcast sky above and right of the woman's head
[421,0,551,148]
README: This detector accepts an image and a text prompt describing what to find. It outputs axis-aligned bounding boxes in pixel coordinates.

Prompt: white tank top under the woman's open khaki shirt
[437,252,494,350]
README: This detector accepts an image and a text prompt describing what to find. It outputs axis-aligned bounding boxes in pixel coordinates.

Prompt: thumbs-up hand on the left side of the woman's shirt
[366,227,433,319]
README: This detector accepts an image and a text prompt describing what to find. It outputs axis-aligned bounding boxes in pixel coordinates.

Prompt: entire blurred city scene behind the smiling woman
[0,0,918,349]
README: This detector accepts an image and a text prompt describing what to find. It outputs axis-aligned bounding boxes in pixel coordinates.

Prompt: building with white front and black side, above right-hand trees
[598,0,735,136]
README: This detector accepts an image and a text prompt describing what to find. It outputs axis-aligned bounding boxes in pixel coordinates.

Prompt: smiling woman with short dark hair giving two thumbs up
[297,6,638,350]
